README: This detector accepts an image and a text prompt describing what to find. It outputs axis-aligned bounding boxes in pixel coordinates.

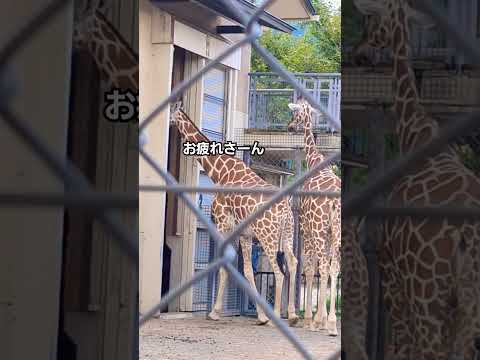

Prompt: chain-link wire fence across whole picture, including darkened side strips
[0,0,480,359]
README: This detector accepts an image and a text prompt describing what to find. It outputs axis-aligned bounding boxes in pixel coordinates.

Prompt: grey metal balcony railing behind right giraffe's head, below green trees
[248,72,341,131]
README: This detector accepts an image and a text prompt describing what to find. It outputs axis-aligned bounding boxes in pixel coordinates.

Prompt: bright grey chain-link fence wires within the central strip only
[140,1,340,359]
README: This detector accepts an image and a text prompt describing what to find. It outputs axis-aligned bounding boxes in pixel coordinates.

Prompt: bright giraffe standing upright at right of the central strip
[288,99,341,336]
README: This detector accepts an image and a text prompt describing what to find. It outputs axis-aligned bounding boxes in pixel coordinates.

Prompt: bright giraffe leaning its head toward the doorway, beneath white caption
[172,107,298,325]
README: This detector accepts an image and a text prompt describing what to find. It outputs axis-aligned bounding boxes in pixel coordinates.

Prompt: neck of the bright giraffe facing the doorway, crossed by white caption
[174,110,244,184]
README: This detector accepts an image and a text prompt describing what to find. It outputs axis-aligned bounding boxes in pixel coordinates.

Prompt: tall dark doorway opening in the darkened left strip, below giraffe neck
[57,52,100,360]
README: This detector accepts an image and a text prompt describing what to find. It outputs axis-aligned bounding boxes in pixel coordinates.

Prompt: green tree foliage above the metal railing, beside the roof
[252,0,341,73]
